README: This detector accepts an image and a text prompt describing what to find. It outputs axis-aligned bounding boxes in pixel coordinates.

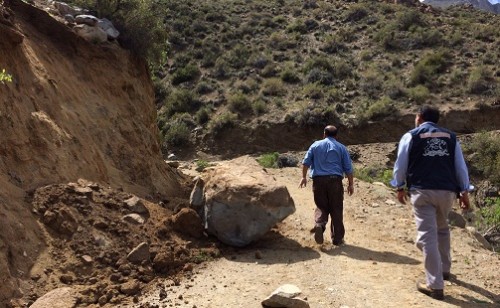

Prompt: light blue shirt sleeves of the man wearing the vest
[391,122,469,192]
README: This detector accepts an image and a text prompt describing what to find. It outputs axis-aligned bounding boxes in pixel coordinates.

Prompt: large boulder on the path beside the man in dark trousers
[197,156,295,247]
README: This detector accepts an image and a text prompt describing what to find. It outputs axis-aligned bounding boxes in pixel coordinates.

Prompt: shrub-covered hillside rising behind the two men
[153,0,500,156]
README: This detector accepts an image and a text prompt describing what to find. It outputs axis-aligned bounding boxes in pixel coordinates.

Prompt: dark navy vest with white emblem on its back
[407,122,460,192]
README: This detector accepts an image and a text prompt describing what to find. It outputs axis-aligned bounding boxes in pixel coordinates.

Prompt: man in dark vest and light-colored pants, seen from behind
[391,106,469,300]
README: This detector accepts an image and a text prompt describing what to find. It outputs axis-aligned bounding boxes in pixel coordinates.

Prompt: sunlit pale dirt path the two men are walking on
[140,160,500,308]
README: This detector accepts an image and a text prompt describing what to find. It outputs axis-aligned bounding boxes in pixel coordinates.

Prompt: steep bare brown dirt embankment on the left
[0,0,185,306]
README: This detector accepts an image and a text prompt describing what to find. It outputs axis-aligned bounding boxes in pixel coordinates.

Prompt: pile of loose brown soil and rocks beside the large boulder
[27,179,219,307]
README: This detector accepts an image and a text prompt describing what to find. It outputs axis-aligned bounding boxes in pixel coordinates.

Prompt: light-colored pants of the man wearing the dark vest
[410,189,456,289]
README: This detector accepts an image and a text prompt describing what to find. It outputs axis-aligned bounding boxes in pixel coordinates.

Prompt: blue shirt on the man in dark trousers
[302,137,353,178]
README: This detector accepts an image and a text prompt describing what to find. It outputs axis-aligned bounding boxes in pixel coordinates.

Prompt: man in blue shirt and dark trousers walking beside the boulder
[299,125,354,246]
